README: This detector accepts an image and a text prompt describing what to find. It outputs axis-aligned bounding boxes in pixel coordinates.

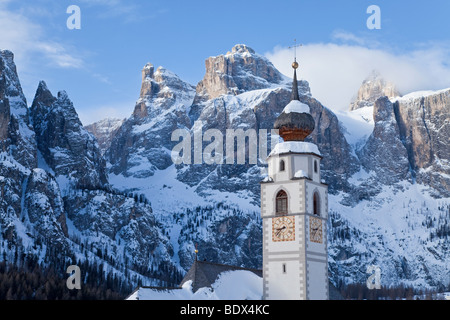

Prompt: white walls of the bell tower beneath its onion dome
[261,147,328,300]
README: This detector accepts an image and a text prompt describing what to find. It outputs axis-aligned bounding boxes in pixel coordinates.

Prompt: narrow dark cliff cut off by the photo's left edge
[0,50,37,243]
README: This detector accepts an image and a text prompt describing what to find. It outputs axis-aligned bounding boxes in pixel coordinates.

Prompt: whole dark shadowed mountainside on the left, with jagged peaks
[0,51,178,286]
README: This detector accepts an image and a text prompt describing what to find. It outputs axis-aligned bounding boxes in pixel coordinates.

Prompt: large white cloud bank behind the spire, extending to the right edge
[266,32,450,110]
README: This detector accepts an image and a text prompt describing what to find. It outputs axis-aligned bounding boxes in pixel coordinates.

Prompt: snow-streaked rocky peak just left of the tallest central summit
[106,64,195,177]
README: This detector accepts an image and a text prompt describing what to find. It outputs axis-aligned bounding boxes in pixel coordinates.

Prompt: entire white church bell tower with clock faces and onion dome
[261,58,329,300]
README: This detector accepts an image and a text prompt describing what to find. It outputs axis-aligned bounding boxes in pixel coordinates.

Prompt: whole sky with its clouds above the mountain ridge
[0,0,450,124]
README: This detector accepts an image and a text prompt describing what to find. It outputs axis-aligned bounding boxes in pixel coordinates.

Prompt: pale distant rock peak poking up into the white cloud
[350,71,400,111]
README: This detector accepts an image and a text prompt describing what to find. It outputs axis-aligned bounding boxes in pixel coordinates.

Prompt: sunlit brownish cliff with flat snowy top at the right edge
[394,89,450,197]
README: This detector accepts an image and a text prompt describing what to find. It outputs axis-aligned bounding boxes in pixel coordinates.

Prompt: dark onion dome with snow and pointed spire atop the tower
[274,62,315,141]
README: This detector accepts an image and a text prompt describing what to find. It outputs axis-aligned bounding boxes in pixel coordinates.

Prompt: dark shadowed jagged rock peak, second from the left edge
[30,81,107,188]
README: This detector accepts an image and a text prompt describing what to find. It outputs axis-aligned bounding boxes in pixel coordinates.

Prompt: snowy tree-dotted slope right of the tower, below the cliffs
[328,182,450,288]
